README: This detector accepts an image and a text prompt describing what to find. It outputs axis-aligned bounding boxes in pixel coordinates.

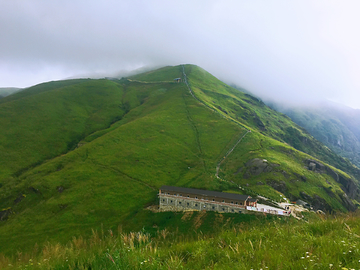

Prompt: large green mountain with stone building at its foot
[0,65,360,252]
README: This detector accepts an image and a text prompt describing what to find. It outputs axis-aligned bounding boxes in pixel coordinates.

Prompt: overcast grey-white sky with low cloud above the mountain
[0,0,360,108]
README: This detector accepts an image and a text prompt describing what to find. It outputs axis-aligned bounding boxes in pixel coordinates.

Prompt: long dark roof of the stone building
[160,186,250,201]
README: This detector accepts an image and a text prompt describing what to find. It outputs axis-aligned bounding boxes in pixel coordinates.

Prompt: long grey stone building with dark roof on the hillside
[159,186,257,213]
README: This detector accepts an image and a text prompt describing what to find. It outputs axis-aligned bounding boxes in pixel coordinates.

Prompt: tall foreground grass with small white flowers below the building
[0,213,360,269]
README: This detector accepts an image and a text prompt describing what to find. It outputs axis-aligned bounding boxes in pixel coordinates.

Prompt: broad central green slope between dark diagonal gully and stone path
[0,67,242,253]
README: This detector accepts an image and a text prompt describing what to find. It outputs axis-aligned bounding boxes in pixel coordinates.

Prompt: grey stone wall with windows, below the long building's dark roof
[159,194,248,213]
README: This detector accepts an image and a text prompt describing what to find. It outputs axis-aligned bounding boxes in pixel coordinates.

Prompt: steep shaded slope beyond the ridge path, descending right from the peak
[188,66,360,179]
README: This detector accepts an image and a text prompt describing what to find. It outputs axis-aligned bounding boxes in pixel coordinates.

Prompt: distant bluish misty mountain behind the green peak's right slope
[272,102,360,167]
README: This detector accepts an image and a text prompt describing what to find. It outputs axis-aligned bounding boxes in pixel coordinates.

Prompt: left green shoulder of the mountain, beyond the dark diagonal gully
[0,80,126,179]
